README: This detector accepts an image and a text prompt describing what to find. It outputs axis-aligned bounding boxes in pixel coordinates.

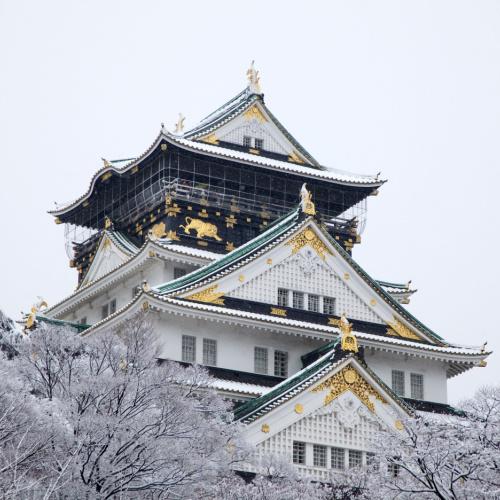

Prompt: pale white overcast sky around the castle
[0,0,500,402]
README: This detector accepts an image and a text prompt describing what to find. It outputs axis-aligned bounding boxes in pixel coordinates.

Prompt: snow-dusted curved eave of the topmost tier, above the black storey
[48,129,386,216]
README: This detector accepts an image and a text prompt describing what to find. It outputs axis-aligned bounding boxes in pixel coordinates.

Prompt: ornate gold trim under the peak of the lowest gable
[311,366,387,413]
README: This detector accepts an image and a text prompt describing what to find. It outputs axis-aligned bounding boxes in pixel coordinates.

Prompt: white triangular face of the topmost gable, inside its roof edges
[201,102,310,164]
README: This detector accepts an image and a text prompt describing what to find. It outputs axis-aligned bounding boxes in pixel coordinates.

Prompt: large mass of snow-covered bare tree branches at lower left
[0,314,324,500]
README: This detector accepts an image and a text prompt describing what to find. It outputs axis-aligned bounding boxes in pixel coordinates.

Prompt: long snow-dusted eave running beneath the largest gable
[84,291,491,364]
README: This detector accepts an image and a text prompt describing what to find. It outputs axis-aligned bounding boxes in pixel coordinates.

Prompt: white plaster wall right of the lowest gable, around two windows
[365,350,448,403]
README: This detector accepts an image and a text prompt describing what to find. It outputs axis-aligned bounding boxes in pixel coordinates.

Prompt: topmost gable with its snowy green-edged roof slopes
[184,88,319,167]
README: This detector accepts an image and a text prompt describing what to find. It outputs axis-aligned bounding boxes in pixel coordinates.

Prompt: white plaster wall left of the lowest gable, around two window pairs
[155,313,323,375]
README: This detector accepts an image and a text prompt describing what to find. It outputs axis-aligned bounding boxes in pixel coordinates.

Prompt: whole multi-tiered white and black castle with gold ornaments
[34,65,489,480]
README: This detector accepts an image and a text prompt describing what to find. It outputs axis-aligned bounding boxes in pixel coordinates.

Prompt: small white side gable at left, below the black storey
[80,231,138,287]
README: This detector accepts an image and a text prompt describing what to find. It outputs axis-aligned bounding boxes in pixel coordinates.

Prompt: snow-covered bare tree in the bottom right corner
[363,387,500,500]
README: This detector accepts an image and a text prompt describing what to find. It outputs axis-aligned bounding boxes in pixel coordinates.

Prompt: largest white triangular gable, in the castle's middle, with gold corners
[171,217,442,344]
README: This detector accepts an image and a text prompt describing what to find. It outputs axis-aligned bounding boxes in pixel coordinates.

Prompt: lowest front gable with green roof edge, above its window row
[235,346,411,446]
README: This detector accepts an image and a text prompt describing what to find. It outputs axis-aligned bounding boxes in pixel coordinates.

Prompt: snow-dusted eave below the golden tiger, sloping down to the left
[44,239,222,317]
